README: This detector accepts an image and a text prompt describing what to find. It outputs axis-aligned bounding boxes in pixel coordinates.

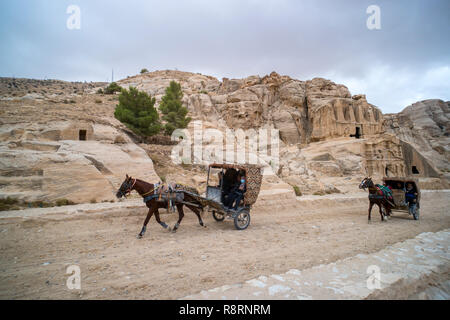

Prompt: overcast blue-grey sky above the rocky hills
[0,0,450,113]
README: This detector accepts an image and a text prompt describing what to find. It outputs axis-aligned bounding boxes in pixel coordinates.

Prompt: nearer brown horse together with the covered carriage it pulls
[116,164,263,238]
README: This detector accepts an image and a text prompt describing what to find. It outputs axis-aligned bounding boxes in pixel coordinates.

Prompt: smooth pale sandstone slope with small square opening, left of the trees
[0,78,159,203]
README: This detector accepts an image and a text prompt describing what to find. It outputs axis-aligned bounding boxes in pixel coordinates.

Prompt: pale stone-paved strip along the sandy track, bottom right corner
[184,229,450,300]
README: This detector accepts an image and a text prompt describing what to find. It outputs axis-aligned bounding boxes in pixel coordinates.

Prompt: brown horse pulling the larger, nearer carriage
[116,175,205,239]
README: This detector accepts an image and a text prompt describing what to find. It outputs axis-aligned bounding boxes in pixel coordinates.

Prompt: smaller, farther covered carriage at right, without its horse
[383,177,420,220]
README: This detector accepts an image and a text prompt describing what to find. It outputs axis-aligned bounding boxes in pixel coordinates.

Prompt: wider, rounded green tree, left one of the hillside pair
[114,87,161,136]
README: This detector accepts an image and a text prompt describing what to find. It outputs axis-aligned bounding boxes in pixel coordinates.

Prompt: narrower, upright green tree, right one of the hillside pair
[159,81,191,136]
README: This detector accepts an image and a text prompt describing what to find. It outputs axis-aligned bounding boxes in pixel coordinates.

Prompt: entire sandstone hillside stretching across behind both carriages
[0,70,449,204]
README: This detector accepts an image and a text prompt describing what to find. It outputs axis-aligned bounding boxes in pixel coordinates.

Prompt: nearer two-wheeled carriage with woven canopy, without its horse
[186,164,263,230]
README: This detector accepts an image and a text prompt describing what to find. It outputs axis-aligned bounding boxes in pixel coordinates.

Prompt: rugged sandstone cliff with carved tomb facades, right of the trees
[119,70,446,194]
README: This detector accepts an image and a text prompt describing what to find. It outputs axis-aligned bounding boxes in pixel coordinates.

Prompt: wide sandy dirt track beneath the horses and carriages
[0,191,450,299]
